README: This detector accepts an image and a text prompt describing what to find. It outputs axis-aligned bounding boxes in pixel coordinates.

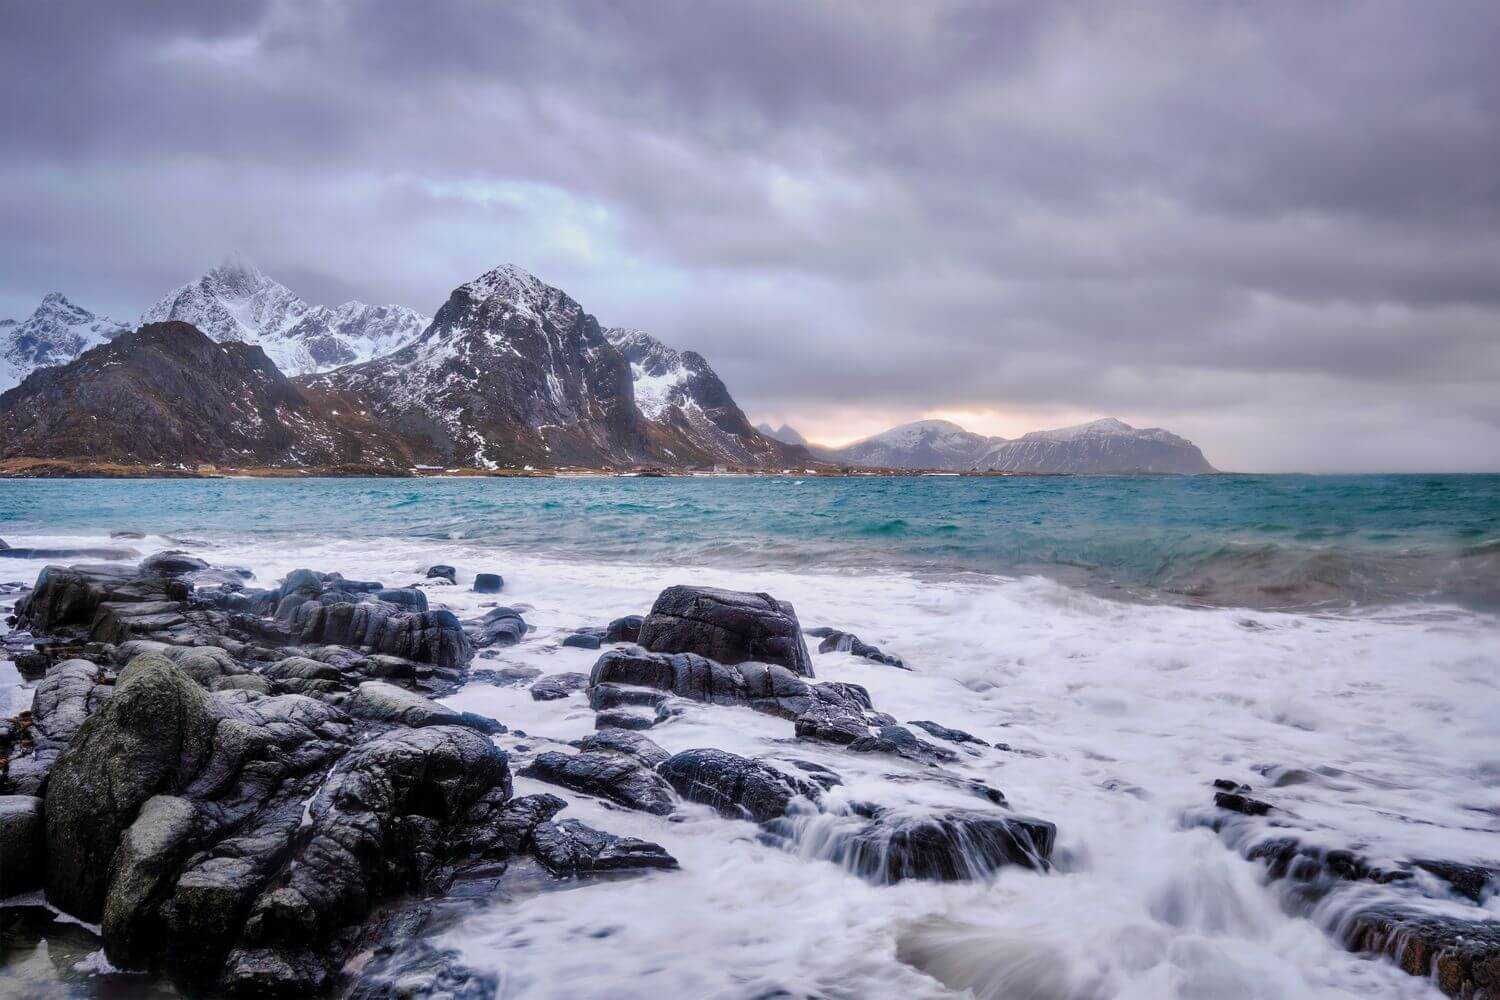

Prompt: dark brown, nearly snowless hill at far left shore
[0,322,411,469]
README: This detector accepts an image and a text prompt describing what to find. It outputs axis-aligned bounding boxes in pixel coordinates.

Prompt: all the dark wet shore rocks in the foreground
[0,550,1500,1000]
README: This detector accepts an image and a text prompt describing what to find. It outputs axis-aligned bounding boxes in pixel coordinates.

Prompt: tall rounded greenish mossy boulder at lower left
[45,654,216,924]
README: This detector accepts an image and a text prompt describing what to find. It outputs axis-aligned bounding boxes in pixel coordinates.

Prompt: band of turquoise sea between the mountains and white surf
[0,475,1500,609]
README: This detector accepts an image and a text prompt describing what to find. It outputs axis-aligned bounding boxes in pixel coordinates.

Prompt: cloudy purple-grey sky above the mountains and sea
[0,0,1500,471]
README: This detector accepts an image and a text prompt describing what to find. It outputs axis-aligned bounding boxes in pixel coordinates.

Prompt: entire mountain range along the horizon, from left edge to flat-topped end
[0,255,1214,474]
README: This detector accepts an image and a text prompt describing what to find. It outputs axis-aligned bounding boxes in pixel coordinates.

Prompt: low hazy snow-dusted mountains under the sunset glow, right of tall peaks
[761,417,1215,475]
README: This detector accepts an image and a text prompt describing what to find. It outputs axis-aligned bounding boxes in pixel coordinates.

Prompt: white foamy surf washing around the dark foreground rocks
[0,524,1500,1000]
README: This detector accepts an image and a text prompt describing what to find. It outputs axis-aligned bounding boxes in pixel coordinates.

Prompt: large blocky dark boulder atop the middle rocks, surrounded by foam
[641,586,813,678]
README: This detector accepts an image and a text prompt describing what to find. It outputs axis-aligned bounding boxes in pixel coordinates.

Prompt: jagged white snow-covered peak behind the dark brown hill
[141,255,432,375]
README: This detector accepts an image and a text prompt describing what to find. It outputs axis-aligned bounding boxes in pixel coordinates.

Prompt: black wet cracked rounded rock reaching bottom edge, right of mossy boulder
[224,726,512,996]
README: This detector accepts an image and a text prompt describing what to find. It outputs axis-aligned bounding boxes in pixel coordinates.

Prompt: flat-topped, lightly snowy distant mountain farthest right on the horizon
[975,417,1217,474]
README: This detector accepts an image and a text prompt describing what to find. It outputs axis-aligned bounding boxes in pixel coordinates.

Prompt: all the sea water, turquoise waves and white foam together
[0,477,1500,1000]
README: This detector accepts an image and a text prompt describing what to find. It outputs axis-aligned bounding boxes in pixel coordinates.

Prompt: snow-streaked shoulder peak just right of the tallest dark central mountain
[605,327,810,466]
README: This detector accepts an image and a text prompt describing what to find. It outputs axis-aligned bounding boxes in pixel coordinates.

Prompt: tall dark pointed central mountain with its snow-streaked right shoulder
[306,264,806,468]
